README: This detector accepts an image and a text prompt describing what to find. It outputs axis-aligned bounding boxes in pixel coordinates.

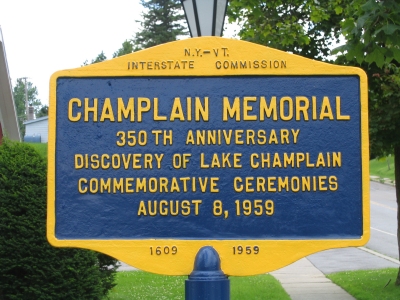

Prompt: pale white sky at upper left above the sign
[0,0,203,104]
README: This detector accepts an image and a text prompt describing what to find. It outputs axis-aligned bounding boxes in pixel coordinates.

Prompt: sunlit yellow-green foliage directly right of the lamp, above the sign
[228,0,350,60]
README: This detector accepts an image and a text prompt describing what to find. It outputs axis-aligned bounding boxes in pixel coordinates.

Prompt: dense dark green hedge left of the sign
[0,141,116,300]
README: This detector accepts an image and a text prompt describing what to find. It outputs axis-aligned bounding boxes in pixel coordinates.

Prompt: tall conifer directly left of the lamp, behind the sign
[133,0,188,51]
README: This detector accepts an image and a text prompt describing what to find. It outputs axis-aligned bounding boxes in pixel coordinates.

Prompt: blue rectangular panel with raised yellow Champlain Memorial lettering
[55,75,363,240]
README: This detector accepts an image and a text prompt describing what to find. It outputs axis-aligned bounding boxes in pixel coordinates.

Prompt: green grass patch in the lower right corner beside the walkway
[327,268,400,300]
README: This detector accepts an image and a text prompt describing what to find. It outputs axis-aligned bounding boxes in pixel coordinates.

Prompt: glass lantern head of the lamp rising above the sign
[181,0,228,37]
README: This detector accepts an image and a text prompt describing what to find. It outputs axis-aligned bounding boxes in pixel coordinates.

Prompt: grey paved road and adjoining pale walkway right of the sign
[271,182,400,300]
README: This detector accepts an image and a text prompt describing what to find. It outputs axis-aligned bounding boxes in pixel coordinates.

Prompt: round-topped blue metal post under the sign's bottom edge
[185,246,230,300]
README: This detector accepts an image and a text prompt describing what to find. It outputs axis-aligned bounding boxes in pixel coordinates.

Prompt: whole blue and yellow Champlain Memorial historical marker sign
[48,37,369,275]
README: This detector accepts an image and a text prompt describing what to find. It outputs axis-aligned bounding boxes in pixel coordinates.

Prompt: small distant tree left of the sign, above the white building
[13,78,42,138]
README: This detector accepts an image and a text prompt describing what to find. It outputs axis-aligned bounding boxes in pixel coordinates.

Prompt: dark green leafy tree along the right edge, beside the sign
[336,0,400,286]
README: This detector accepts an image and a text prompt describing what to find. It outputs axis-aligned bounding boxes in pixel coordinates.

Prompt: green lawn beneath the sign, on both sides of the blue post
[109,271,290,300]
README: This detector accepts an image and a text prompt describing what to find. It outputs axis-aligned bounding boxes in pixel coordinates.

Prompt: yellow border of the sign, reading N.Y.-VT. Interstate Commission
[47,37,370,276]
